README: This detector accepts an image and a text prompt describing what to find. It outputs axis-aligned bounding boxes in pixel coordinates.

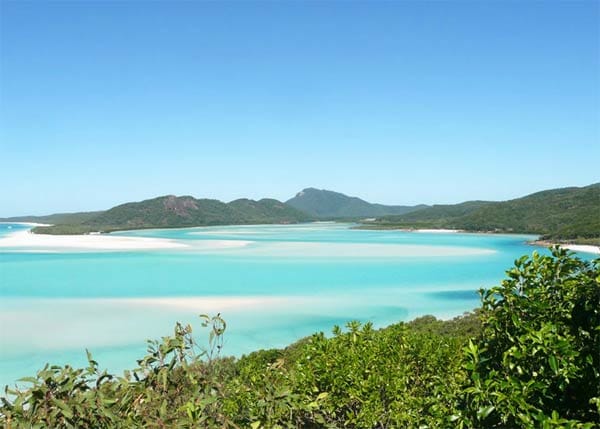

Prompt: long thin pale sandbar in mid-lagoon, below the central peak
[227,241,496,258]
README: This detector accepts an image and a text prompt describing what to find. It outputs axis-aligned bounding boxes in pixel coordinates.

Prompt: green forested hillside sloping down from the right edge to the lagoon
[371,183,600,240]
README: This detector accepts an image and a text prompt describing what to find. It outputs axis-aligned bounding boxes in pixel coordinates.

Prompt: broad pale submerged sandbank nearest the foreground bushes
[0,296,308,352]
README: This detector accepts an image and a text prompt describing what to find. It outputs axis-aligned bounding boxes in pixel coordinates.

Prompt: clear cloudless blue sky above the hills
[0,0,600,216]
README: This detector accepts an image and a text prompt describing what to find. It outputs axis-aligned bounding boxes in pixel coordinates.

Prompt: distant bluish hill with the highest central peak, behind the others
[286,188,427,219]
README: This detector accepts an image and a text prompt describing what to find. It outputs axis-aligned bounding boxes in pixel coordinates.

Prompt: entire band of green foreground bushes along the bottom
[0,249,600,429]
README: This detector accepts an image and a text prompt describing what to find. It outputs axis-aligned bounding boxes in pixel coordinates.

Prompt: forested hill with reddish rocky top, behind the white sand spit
[25,195,311,234]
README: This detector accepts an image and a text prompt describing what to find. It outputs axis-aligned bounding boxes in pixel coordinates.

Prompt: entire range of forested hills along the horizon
[2,183,600,245]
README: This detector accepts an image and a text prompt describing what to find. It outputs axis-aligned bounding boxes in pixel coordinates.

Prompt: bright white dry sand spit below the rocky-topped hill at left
[0,231,188,250]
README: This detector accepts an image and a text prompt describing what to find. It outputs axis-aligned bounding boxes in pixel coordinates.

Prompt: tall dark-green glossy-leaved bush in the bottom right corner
[463,248,600,427]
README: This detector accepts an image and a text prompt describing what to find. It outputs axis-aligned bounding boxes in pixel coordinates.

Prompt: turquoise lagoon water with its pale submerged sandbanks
[0,223,568,384]
